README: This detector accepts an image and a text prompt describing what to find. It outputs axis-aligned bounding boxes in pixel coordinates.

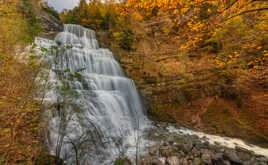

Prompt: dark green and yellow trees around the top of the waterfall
[61,0,135,50]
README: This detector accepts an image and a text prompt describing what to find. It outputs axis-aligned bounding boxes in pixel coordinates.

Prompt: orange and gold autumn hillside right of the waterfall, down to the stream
[61,0,268,144]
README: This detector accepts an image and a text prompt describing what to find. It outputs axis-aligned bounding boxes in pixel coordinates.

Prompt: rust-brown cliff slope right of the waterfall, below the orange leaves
[99,23,268,147]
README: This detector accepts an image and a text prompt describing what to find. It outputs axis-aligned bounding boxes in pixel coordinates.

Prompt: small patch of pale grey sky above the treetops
[45,0,79,12]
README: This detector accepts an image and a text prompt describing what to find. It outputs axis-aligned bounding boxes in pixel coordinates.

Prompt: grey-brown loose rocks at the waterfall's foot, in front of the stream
[141,135,268,165]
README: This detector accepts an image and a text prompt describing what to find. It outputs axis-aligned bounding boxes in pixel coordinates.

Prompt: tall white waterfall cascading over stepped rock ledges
[36,24,150,165]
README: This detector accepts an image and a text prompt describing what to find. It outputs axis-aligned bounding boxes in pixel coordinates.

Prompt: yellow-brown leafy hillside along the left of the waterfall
[0,0,60,165]
